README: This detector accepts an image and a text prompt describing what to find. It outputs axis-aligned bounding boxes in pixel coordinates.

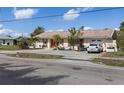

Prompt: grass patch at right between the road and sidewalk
[92,58,124,67]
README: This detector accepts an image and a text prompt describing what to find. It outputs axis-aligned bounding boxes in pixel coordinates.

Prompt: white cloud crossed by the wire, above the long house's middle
[63,7,93,20]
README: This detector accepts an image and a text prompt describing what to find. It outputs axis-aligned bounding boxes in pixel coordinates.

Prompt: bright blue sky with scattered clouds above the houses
[0,7,124,37]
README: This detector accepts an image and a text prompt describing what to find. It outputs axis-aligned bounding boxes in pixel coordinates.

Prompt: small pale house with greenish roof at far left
[0,36,14,45]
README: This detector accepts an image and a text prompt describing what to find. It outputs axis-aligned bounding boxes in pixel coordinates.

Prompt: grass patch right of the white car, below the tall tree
[102,51,124,57]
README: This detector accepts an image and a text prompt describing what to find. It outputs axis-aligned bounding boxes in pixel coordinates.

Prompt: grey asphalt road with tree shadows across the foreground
[0,54,124,85]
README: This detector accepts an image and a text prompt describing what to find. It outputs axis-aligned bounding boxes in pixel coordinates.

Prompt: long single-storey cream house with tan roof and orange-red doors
[36,29,117,51]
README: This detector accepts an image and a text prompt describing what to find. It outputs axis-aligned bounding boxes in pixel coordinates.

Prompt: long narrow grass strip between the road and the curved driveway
[7,53,63,59]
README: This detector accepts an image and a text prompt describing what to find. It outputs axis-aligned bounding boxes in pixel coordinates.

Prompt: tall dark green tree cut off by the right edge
[117,22,124,52]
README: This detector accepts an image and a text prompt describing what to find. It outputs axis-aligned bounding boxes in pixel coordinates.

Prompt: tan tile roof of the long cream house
[37,29,114,39]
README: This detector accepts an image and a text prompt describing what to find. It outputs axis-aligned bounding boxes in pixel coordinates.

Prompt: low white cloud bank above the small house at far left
[0,24,29,37]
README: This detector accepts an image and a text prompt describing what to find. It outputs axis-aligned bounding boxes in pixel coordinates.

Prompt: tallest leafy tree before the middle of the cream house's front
[68,27,82,50]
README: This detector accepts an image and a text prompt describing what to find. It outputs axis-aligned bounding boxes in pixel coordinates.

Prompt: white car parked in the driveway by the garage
[87,43,103,53]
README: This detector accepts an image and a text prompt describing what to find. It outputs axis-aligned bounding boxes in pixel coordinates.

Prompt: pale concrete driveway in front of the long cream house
[0,49,101,60]
